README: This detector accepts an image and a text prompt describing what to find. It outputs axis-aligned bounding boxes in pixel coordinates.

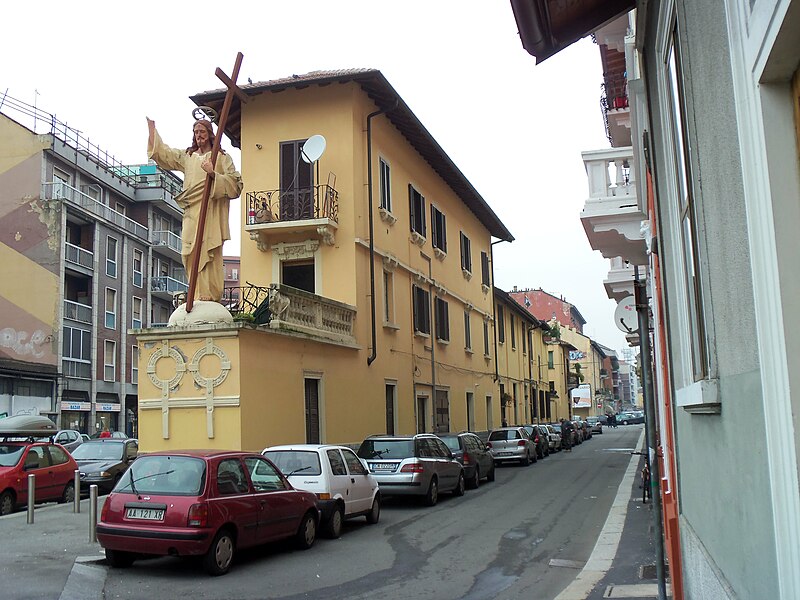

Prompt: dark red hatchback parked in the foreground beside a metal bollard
[97,450,320,575]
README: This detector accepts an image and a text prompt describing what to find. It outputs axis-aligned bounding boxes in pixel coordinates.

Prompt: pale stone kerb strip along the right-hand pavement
[556,431,644,600]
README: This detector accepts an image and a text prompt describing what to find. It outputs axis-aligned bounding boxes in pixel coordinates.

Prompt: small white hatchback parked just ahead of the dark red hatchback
[261,444,381,538]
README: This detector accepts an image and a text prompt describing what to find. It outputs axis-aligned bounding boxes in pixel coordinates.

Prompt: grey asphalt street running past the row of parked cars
[0,425,642,600]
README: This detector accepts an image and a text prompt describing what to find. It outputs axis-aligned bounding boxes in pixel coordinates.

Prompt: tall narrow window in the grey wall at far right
[667,39,708,381]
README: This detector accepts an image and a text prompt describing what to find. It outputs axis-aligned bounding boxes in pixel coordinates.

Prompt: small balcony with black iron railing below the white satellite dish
[244,184,339,252]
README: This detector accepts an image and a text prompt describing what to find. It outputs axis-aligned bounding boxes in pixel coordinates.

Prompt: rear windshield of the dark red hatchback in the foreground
[117,458,206,496]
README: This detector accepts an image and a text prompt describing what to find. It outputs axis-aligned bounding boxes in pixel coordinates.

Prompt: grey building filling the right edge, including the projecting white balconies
[512,0,800,600]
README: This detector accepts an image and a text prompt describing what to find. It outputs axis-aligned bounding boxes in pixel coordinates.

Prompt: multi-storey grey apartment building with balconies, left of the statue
[0,96,186,434]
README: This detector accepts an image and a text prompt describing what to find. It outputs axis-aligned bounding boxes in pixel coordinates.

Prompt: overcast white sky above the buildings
[0,0,627,351]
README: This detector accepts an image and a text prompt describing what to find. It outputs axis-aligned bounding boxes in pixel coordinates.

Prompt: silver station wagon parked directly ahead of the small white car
[358,433,466,506]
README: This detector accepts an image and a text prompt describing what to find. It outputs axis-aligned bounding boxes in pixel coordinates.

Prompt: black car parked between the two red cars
[72,438,139,494]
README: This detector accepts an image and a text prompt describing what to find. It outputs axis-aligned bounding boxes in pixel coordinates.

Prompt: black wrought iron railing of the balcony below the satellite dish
[245,184,339,225]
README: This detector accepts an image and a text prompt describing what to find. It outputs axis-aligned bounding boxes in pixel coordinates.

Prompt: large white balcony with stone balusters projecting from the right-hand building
[581,147,647,265]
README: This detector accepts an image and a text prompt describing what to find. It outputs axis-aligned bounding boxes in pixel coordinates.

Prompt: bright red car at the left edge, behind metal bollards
[0,435,78,515]
